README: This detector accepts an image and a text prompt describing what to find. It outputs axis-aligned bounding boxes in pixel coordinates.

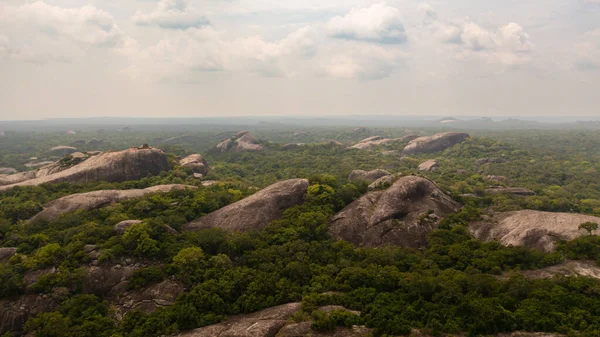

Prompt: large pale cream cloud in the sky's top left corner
[0,1,128,62]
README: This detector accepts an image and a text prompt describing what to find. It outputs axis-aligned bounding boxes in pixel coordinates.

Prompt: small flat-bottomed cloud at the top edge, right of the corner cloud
[132,0,209,29]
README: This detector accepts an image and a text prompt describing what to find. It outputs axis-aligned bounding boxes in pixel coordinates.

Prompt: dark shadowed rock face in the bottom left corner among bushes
[0,295,58,335]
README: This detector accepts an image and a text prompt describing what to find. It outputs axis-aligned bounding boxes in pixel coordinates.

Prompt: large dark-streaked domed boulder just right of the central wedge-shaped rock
[329,176,460,247]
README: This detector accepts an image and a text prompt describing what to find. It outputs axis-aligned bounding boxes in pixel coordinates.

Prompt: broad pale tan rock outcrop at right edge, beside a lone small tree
[470,210,600,252]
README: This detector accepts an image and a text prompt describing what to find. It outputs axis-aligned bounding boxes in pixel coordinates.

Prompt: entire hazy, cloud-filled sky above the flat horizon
[0,0,600,120]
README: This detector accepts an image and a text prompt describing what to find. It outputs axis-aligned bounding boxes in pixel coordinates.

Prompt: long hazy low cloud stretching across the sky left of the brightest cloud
[121,27,316,79]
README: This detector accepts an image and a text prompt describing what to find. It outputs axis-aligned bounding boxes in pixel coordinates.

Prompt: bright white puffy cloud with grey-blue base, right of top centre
[326,4,407,44]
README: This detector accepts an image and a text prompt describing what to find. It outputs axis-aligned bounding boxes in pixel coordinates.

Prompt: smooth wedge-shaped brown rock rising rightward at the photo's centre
[184,179,308,232]
